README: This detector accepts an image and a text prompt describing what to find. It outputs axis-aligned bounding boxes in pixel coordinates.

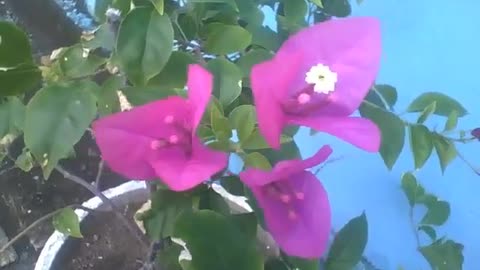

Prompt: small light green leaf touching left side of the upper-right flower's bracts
[228,105,257,142]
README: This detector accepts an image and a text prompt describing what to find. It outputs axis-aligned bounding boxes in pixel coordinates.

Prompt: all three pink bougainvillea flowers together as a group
[93,17,381,258]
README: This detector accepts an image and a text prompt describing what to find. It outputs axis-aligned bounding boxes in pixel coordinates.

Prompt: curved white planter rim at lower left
[34,180,148,270]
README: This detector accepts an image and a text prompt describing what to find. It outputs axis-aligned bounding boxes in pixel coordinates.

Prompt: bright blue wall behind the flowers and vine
[258,0,480,270]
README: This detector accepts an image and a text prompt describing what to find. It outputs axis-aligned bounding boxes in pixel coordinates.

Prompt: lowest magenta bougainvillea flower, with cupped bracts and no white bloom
[240,146,332,258]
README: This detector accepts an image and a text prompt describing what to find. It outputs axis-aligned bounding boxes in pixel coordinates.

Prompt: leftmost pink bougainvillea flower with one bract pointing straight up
[93,65,228,191]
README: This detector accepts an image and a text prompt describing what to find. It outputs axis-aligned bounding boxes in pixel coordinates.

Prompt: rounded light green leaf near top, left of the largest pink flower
[204,22,252,55]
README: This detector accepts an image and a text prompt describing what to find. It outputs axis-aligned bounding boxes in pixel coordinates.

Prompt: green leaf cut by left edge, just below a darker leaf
[0,64,42,97]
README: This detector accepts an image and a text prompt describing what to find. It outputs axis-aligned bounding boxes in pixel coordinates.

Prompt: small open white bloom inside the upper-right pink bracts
[305,64,337,94]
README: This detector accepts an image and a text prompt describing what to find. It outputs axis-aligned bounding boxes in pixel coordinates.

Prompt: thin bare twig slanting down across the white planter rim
[55,165,149,251]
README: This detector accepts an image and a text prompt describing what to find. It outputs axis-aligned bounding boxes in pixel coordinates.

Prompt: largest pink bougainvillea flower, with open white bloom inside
[251,17,381,152]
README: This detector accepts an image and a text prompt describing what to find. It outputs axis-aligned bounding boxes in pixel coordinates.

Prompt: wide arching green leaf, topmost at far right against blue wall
[407,92,468,117]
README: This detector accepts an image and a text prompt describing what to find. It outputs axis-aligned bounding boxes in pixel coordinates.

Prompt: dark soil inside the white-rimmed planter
[52,202,146,270]
